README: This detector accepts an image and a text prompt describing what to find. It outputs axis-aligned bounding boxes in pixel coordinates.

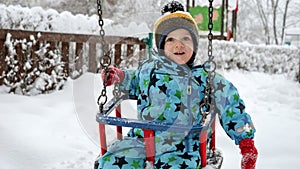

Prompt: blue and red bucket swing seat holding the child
[94,94,223,169]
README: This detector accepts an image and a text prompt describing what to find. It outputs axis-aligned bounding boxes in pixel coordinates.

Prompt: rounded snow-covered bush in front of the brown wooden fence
[1,34,66,95]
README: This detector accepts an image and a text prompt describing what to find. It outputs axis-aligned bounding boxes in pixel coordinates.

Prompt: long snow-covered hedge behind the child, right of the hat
[198,40,300,82]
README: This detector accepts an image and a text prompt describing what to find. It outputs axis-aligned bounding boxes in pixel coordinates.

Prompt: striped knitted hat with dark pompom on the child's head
[154,1,199,65]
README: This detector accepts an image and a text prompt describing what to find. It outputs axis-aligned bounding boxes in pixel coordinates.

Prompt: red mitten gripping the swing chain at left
[101,66,124,86]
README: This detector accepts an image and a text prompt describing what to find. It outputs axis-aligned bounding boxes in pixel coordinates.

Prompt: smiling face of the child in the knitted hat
[164,29,194,64]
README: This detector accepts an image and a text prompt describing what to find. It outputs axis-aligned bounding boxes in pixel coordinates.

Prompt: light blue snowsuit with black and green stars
[98,56,255,169]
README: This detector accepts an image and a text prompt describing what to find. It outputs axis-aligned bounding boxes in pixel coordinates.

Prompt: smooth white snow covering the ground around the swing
[0,71,300,169]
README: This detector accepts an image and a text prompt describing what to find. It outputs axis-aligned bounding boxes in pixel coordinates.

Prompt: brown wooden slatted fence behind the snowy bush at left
[0,29,146,85]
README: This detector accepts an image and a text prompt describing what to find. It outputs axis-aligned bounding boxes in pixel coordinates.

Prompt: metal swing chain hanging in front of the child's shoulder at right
[199,0,216,124]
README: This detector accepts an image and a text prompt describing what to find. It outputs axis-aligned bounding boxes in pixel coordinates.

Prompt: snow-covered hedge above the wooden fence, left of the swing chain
[0,4,101,34]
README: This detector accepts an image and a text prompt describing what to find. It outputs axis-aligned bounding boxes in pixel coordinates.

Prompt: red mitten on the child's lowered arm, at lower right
[239,139,258,169]
